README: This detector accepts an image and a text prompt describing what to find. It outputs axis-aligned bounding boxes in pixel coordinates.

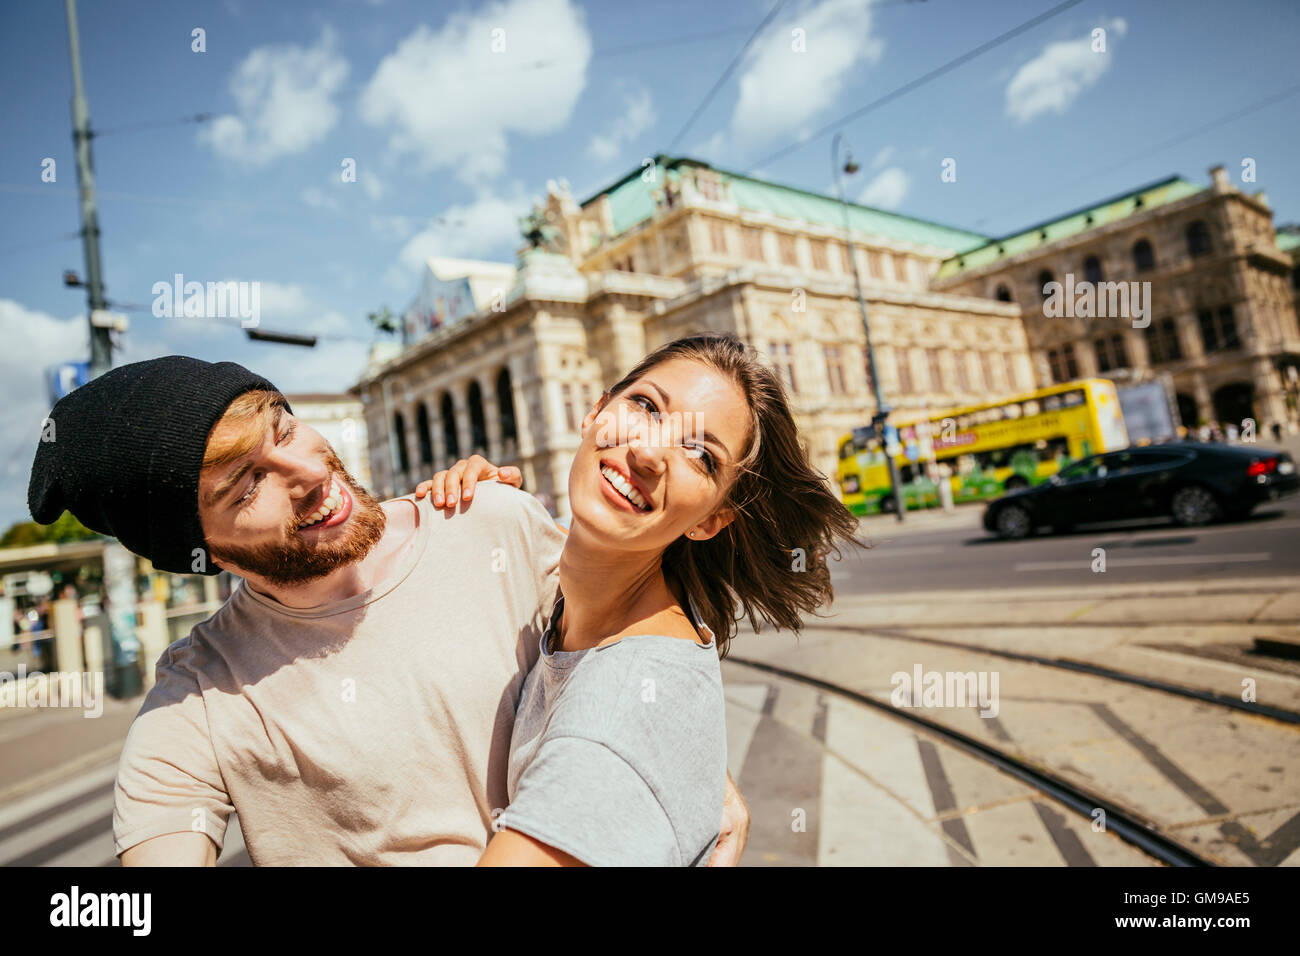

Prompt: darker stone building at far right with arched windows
[935,166,1300,431]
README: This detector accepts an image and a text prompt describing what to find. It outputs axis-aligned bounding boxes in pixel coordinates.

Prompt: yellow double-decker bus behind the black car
[839,378,1128,515]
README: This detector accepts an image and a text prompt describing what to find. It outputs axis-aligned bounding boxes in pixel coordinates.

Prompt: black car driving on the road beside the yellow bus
[984,442,1300,538]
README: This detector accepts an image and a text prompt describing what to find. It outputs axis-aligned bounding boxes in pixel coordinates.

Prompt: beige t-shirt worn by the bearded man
[113,481,564,865]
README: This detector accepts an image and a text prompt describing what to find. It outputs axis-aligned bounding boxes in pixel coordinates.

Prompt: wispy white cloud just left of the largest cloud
[199,27,350,165]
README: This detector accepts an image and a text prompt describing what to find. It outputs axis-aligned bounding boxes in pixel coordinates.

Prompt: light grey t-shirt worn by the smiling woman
[494,598,727,866]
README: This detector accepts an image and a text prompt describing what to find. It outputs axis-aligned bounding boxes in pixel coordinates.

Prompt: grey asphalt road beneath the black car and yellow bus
[832,496,1300,596]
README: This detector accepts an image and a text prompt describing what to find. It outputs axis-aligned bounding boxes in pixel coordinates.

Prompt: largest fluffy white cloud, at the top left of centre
[360,0,592,182]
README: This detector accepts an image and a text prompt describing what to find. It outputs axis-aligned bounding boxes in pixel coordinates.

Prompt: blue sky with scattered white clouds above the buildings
[0,0,1300,527]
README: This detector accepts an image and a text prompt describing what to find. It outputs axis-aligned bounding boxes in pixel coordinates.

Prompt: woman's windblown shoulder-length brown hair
[601,333,859,657]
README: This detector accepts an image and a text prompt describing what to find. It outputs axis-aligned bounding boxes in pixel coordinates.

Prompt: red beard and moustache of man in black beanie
[211,450,387,588]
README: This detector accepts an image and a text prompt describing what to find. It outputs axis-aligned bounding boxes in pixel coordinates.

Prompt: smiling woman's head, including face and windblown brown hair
[569,334,857,656]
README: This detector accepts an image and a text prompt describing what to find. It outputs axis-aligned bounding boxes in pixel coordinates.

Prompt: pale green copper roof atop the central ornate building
[582,156,989,252]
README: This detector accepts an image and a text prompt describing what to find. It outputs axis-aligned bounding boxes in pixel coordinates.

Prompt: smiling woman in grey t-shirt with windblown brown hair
[467,334,857,866]
